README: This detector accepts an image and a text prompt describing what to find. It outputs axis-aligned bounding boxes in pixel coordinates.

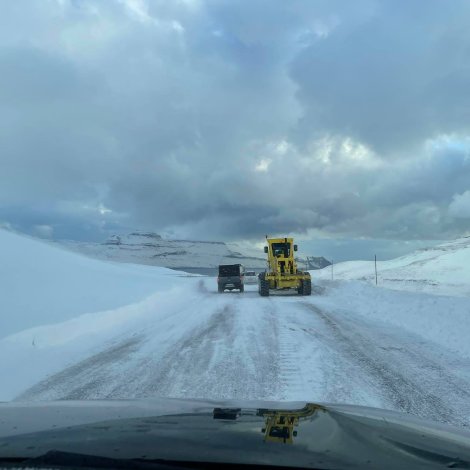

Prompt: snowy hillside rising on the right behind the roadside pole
[313,238,470,296]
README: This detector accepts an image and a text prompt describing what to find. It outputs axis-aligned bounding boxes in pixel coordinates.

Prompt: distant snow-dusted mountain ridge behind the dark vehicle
[60,232,266,272]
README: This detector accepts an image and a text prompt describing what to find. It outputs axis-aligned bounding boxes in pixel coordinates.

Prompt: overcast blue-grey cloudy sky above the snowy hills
[0,0,470,257]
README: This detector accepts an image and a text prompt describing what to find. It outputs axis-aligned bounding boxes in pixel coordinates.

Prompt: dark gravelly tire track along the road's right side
[303,303,470,426]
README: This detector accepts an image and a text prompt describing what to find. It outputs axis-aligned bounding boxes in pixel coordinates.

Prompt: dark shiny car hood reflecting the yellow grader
[0,399,470,469]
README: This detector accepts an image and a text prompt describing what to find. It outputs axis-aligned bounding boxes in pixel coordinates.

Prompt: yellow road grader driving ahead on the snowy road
[258,236,312,297]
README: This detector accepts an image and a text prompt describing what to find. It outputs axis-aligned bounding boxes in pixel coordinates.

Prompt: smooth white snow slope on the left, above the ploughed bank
[0,229,187,338]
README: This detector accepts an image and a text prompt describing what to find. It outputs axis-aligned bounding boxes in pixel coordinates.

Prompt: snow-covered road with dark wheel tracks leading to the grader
[17,278,470,426]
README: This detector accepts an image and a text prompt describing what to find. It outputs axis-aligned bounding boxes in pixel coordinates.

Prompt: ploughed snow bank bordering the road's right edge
[315,281,470,358]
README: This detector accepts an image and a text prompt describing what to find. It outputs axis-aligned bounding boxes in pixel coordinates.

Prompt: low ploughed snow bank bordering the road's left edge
[0,280,214,401]
